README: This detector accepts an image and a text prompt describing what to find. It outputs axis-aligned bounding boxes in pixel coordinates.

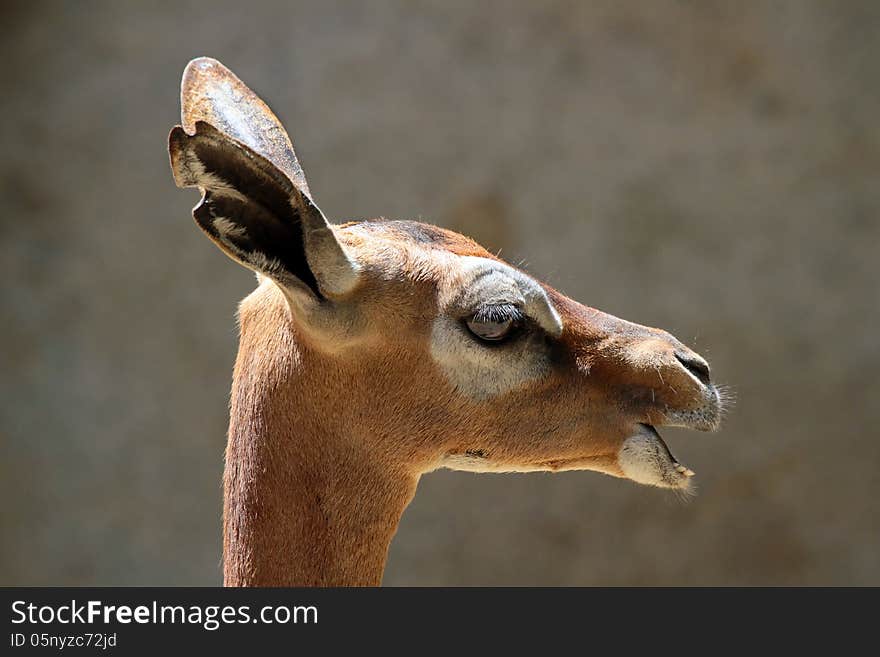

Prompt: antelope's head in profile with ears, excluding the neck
[169,59,722,489]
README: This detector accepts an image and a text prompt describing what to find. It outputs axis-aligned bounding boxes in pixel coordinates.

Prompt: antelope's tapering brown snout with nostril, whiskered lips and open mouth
[553,295,727,490]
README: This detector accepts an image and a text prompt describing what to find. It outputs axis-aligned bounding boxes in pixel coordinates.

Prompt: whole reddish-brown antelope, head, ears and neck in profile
[169,58,723,586]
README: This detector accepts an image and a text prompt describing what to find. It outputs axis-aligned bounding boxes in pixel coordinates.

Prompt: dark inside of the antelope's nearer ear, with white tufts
[169,121,327,298]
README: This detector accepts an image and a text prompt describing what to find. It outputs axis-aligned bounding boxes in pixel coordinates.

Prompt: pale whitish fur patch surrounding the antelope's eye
[431,256,562,400]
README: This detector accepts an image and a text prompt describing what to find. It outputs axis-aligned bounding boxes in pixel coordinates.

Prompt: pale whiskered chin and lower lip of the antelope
[617,423,694,490]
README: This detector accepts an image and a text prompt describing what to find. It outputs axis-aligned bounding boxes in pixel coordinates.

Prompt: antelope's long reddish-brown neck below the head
[223,288,416,586]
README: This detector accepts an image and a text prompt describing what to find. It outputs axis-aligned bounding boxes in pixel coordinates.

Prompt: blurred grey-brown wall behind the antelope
[0,0,880,585]
